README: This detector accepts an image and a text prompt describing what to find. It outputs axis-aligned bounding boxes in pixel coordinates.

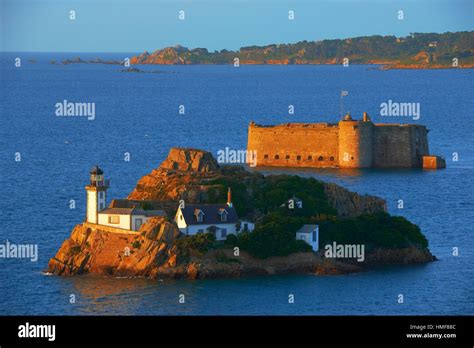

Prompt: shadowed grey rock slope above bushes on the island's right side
[324,183,387,218]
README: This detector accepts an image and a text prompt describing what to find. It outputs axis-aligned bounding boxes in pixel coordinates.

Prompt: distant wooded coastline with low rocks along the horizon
[40,31,474,70]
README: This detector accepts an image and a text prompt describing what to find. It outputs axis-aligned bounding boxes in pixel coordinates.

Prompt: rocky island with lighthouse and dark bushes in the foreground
[48,148,435,279]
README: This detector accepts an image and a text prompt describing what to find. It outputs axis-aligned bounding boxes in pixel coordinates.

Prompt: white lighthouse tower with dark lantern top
[86,165,109,224]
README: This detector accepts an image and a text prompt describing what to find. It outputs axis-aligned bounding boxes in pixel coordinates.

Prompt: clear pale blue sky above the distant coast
[0,0,474,52]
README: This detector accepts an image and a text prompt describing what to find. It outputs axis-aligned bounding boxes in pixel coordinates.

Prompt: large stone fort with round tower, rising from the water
[247,112,446,169]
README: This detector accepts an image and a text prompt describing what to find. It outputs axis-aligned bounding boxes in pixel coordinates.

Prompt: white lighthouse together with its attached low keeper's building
[86,166,166,231]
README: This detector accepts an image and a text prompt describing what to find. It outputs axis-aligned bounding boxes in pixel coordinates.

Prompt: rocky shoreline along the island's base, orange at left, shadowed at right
[48,218,436,279]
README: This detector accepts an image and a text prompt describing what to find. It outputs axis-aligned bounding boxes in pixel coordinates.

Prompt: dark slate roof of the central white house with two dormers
[180,204,239,225]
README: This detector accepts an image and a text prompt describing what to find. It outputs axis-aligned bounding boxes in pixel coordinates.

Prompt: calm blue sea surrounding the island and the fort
[0,53,474,315]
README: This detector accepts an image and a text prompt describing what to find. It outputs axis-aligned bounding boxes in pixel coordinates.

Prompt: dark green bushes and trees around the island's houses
[201,173,428,258]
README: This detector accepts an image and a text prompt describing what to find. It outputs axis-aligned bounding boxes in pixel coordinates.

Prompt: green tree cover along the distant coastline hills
[135,31,474,65]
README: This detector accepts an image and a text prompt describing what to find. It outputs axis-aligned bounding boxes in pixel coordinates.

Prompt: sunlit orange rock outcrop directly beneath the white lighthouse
[48,217,180,277]
